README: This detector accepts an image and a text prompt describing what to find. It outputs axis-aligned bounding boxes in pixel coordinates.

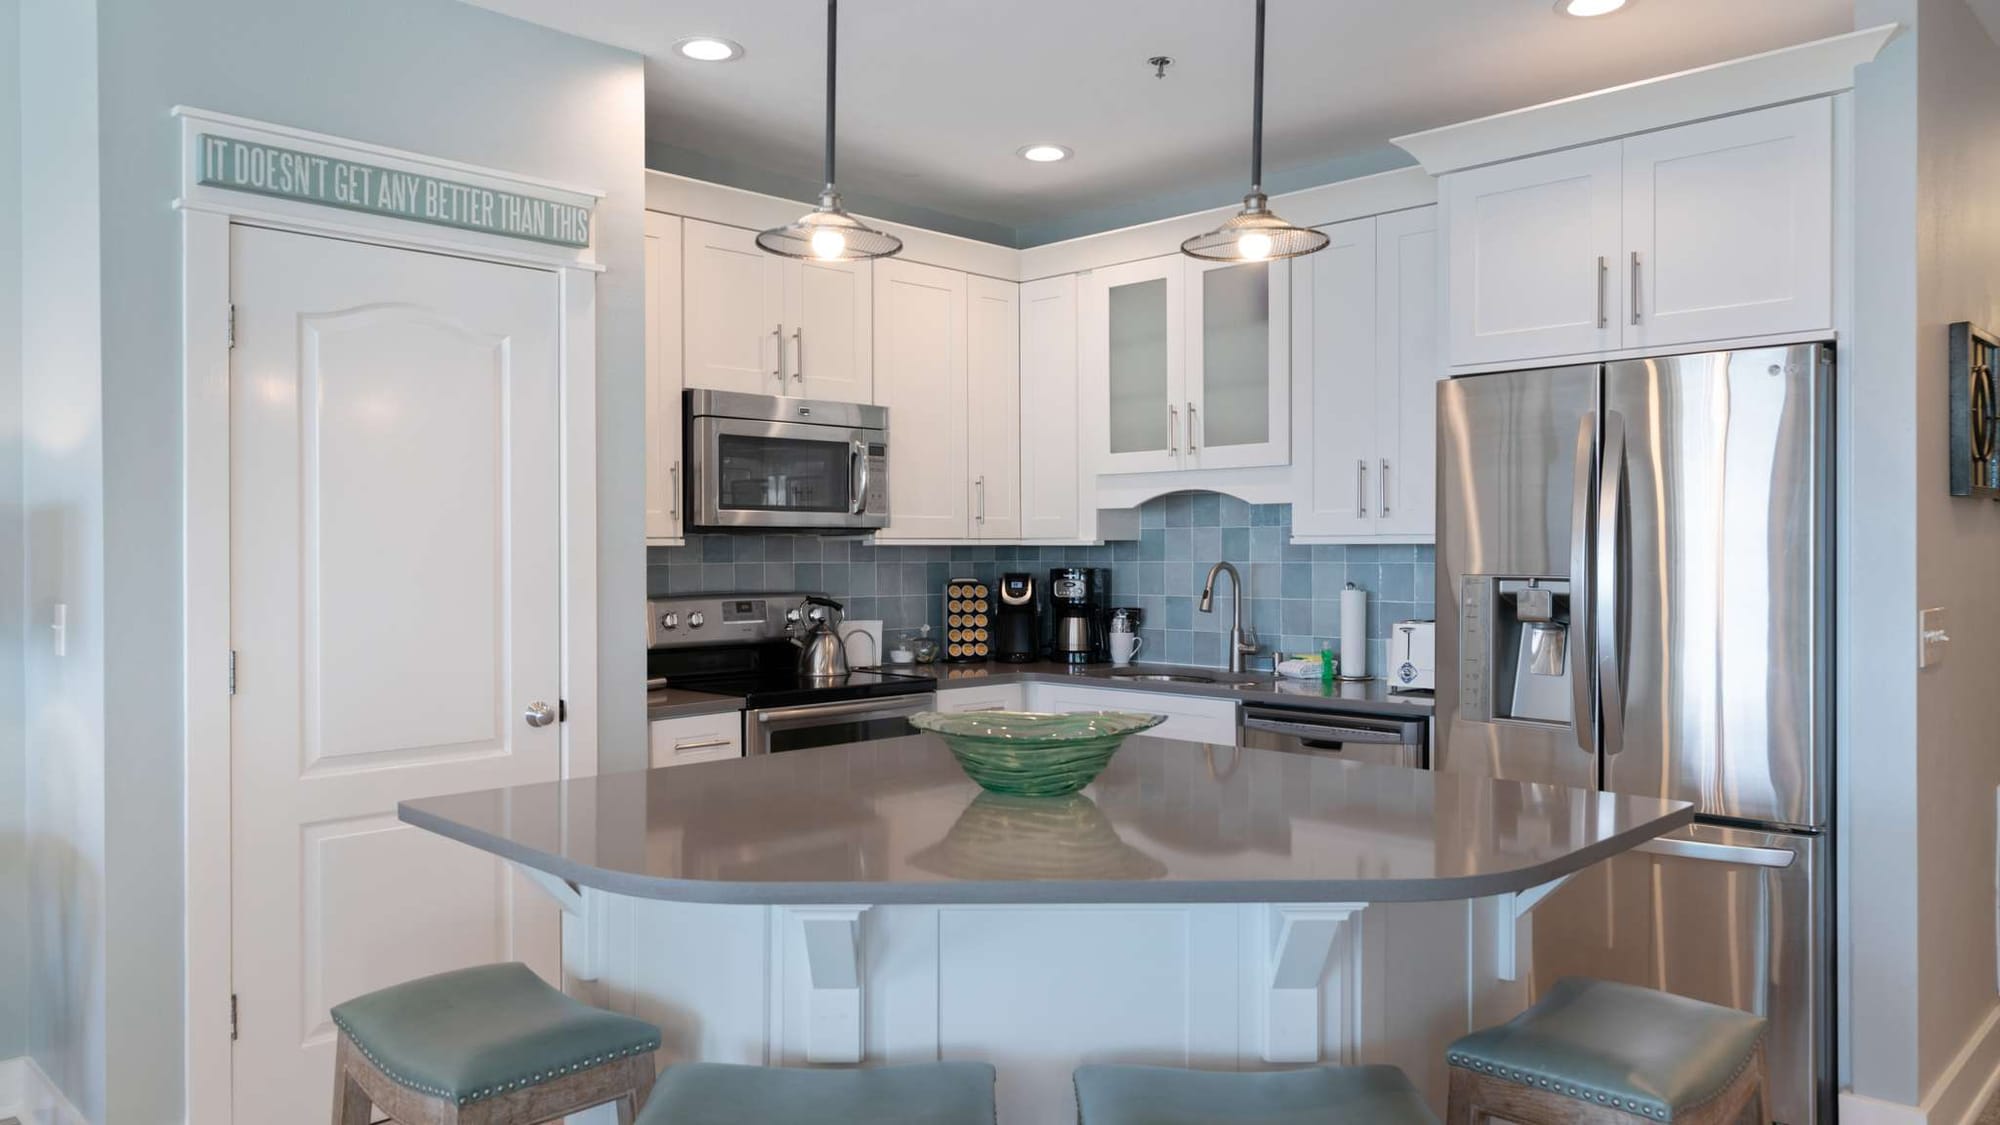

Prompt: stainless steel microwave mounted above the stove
[684,390,888,532]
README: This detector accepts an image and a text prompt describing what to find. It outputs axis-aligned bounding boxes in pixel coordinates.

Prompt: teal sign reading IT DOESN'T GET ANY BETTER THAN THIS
[198,132,590,248]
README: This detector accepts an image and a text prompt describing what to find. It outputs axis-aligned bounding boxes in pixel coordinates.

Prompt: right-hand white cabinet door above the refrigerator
[1618,98,1834,348]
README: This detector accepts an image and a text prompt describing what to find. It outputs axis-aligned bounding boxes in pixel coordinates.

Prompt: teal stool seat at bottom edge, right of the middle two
[1076,1065,1438,1125]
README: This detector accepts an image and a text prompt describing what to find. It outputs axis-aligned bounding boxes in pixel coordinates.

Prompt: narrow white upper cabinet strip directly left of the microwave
[646,212,682,546]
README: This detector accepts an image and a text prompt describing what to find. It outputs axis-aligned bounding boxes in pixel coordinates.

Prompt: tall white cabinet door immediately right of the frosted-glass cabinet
[1292,218,1384,536]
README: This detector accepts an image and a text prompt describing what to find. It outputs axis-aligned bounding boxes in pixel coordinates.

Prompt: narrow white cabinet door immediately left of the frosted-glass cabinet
[1020,274,1084,538]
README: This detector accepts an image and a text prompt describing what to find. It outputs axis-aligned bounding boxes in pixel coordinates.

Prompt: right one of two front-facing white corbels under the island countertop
[1264,903,1366,1065]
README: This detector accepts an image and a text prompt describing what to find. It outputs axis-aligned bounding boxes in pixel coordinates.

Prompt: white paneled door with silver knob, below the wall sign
[230,226,560,1123]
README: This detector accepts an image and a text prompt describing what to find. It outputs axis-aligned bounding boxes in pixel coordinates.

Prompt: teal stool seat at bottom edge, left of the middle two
[638,1063,996,1125]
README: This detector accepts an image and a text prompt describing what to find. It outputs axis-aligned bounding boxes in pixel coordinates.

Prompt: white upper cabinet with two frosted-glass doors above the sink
[1084,254,1292,472]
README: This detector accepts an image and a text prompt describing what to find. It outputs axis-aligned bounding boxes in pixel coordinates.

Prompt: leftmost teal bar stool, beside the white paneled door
[334,965,660,1125]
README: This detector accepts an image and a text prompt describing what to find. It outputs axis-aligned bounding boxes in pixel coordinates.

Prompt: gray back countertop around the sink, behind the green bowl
[882,661,1436,719]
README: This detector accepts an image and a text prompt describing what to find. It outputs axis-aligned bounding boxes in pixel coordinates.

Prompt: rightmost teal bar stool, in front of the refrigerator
[1446,977,1770,1125]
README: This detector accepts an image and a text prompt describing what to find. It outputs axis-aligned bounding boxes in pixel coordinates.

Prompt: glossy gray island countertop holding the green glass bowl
[400,735,1694,905]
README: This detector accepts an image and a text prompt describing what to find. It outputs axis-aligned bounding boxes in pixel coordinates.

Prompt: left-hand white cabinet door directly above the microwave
[682,218,788,394]
